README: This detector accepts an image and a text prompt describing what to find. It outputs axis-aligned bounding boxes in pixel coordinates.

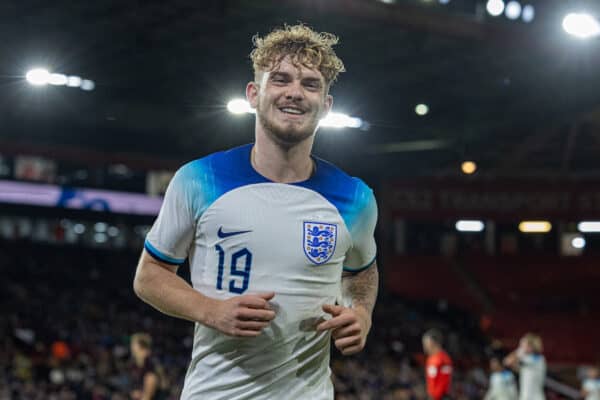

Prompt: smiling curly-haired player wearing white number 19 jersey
[134,25,378,400]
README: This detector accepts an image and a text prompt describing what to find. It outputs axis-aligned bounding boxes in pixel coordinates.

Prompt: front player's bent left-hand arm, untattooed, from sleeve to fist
[133,250,275,337]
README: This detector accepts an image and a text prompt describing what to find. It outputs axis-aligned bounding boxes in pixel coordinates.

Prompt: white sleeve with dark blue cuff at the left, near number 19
[144,167,196,265]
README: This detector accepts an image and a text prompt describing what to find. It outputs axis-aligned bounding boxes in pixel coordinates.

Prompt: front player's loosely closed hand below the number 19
[206,292,275,337]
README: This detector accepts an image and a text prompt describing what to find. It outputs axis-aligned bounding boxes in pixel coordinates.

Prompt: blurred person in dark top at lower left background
[130,333,164,400]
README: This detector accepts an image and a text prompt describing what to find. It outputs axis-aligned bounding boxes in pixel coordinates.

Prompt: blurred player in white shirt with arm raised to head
[504,333,546,400]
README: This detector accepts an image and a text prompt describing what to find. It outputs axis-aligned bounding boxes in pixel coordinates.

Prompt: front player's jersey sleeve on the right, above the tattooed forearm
[344,181,377,272]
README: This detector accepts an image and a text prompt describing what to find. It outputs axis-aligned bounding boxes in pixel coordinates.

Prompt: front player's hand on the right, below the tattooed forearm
[317,304,371,356]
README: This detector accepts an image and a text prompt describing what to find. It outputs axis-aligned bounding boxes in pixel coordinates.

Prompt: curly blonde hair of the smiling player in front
[250,24,345,86]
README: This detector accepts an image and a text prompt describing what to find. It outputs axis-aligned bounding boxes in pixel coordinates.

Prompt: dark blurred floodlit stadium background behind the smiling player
[0,0,600,399]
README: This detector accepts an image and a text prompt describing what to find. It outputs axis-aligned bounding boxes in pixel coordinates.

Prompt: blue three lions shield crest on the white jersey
[303,222,337,265]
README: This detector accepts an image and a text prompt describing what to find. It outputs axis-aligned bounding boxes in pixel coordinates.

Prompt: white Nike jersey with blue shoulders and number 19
[145,145,377,400]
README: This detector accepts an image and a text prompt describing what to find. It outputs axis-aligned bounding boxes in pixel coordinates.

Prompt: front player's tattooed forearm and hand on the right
[317,262,379,355]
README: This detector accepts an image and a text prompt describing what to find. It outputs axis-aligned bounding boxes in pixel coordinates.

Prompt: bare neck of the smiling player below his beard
[251,126,315,183]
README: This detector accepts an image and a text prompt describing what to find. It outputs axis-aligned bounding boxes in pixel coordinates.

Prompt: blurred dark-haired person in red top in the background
[423,329,452,400]
